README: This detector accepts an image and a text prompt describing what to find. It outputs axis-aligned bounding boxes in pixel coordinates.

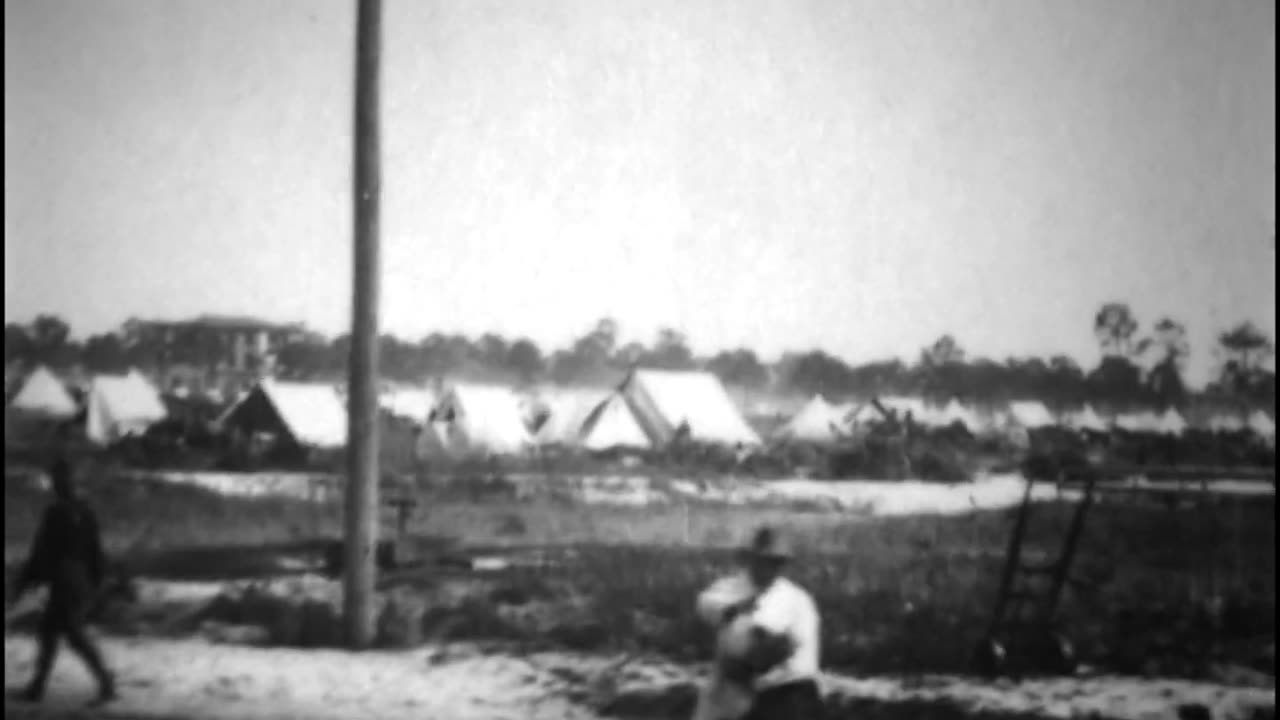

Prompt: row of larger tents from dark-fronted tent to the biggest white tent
[218,370,760,456]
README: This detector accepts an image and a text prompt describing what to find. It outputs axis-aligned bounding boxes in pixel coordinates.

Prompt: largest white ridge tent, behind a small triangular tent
[621,370,760,446]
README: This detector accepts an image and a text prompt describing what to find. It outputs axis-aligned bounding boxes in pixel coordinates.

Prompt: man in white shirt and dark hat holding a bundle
[696,520,822,720]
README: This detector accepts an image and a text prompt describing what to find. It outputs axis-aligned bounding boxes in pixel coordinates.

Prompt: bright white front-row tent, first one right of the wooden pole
[434,383,534,455]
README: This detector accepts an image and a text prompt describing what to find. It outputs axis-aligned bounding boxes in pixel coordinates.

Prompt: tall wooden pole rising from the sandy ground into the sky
[343,0,383,650]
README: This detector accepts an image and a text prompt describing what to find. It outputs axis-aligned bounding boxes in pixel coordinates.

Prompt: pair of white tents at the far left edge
[5,366,168,445]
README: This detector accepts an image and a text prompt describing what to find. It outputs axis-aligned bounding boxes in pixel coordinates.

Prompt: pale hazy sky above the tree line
[4,0,1276,386]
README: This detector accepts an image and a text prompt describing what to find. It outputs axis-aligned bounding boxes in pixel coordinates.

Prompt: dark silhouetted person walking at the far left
[15,459,115,705]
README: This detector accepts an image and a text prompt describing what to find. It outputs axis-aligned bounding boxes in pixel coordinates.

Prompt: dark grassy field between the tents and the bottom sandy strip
[5,468,1275,675]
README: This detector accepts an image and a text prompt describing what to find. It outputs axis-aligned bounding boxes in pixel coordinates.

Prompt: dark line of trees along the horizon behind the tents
[5,302,1275,407]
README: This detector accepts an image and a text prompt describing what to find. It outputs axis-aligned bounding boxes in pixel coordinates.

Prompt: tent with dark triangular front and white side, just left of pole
[218,380,347,448]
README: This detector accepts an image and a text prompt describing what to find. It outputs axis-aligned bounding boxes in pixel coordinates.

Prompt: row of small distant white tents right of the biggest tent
[777,396,1275,443]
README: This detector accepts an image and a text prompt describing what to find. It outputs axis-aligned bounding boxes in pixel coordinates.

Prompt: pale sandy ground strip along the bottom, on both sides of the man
[5,637,1275,720]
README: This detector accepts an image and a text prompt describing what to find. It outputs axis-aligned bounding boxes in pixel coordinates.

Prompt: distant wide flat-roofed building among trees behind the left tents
[124,315,307,375]
